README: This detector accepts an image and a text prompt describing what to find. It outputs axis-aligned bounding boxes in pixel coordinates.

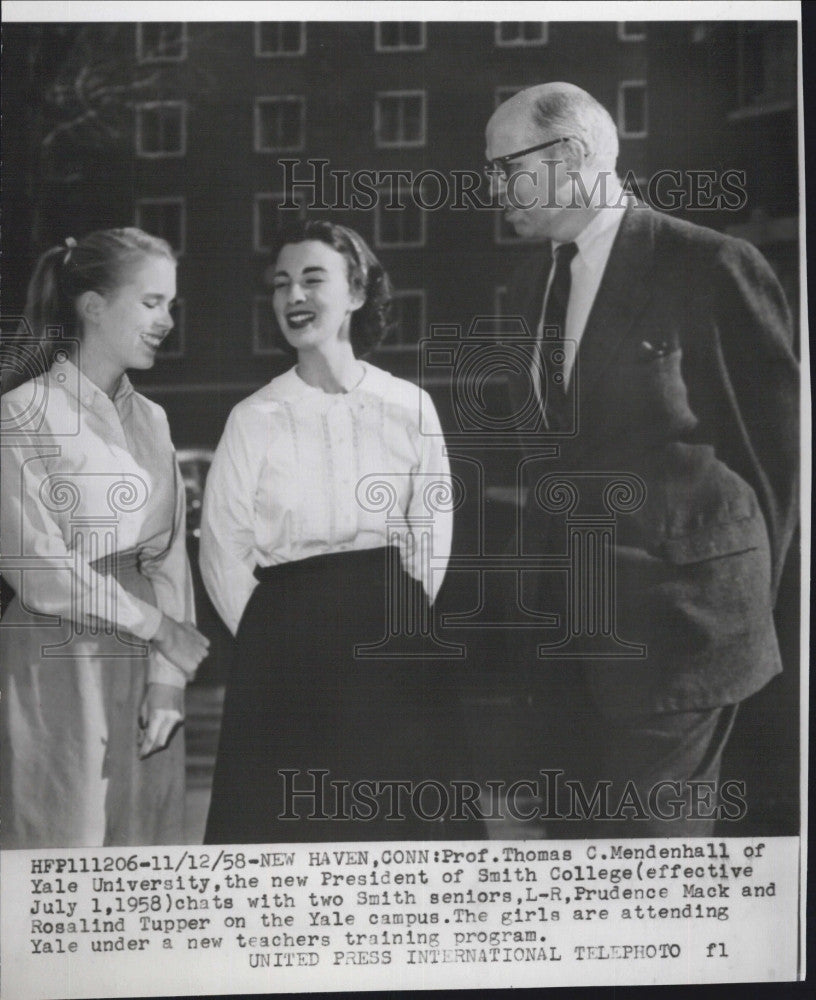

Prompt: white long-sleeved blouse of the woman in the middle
[201,362,453,633]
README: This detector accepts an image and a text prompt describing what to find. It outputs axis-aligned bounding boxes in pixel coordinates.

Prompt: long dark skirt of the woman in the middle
[205,548,477,843]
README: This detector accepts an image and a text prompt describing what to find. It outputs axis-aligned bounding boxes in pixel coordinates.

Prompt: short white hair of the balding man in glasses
[510,83,618,169]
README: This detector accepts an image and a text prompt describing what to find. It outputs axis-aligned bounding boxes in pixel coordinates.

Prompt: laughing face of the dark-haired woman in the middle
[272,240,365,351]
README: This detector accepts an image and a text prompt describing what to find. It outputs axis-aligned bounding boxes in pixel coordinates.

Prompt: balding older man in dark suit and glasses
[486,83,798,837]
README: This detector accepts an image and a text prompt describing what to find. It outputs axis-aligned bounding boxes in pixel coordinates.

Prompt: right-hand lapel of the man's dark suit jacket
[576,204,655,413]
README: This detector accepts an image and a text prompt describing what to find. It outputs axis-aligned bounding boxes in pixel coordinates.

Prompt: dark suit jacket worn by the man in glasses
[509,204,799,718]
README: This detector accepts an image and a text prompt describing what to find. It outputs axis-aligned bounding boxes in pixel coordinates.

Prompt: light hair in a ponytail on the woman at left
[3,226,176,391]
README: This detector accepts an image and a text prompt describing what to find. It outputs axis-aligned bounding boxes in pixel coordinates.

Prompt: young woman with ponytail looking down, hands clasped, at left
[0,228,208,848]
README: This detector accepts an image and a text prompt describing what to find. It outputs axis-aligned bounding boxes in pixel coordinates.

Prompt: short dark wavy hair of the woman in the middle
[272,220,394,357]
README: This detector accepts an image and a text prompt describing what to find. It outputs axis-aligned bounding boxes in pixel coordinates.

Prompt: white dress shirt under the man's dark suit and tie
[537,187,628,386]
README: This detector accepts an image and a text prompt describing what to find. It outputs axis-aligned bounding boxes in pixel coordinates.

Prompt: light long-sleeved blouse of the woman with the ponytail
[0,356,194,687]
